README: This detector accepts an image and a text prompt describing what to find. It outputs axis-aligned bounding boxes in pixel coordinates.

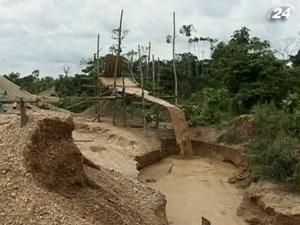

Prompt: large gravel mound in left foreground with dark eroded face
[0,112,166,225]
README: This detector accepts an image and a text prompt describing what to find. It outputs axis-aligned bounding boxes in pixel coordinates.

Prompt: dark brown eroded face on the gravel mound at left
[24,117,88,188]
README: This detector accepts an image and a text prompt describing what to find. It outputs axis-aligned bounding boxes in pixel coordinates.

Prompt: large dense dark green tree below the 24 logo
[206,27,289,112]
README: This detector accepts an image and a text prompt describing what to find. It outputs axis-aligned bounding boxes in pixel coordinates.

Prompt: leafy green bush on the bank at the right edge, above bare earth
[246,104,300,191]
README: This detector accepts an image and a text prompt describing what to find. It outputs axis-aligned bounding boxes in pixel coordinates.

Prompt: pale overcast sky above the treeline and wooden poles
[0,0,300,76]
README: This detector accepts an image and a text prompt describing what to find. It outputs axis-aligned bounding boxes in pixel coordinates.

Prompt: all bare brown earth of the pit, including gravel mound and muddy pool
[0,107,300,225]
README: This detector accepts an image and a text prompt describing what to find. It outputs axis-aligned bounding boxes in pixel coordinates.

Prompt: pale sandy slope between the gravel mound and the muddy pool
[73,117,161,179]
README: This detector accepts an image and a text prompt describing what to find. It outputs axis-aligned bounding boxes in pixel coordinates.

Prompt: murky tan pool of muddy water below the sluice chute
[139,157,245,225]
